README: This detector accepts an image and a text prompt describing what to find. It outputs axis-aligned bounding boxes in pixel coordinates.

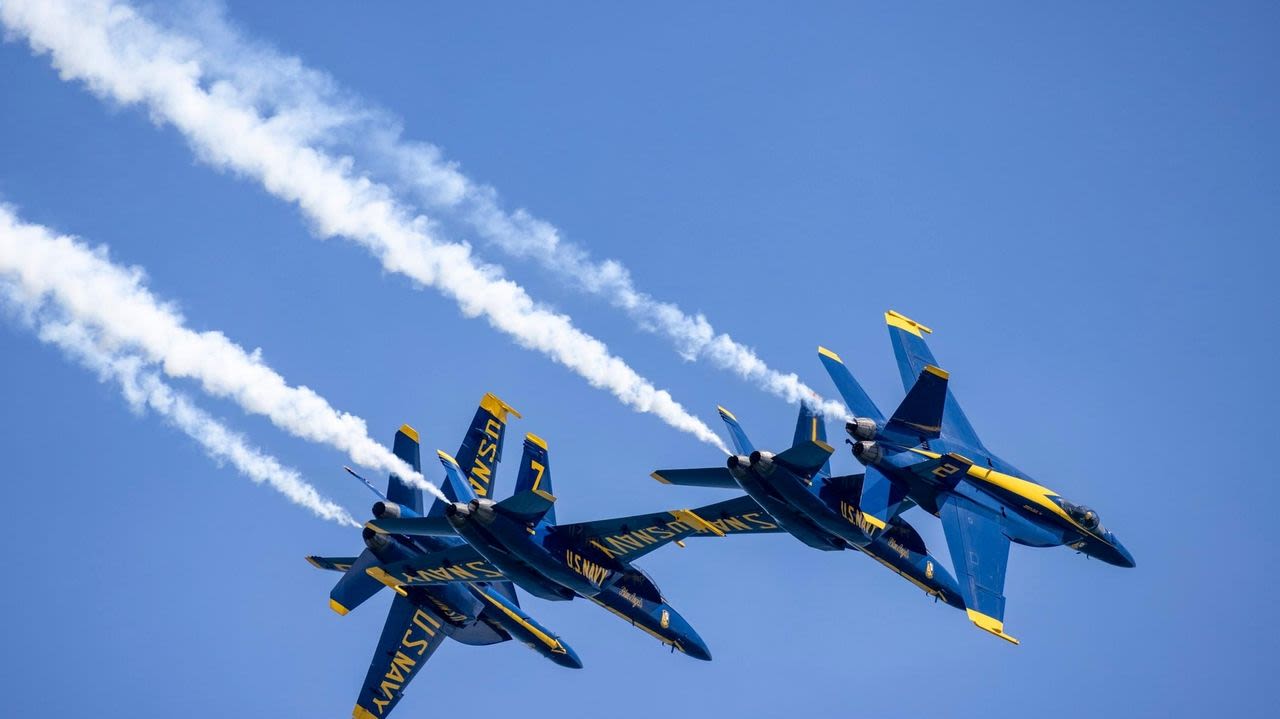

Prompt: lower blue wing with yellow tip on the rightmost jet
[940,494,1018,644]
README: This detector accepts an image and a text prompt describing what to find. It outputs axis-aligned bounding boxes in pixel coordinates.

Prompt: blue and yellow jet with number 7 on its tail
[366,435,723,660]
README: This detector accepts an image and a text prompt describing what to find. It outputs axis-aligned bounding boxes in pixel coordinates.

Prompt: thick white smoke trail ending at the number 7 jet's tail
[0,206,443,496]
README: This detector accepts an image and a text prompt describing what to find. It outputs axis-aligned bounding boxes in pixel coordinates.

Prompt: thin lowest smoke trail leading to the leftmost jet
[0,280,360,527]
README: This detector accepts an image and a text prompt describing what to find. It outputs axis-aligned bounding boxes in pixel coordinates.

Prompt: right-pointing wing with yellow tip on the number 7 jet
[556,509,724,563]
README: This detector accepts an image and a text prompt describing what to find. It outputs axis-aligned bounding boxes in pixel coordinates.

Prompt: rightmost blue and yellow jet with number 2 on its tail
[818,310,1134,644]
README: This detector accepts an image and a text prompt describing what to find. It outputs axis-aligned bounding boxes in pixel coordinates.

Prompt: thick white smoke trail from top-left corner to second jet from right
[0,0,728,453]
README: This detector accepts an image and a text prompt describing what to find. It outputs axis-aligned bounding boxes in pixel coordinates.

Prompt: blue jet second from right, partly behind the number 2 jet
[652,406,964,609]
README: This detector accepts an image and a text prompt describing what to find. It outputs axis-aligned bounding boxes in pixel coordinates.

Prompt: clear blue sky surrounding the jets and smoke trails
[0,1,1280,719]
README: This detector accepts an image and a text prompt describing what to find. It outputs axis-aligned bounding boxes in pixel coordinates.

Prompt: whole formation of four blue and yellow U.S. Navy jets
[307,311,1134,719]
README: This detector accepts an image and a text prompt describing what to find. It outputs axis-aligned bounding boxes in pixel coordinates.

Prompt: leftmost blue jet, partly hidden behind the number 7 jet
[307,394,582,719]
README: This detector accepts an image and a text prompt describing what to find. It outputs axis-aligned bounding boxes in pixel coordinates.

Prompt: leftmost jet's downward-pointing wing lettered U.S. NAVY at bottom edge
[352,595,452,719]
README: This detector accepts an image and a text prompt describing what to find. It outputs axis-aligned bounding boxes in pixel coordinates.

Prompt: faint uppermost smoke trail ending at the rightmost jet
[142,5,847,417]
